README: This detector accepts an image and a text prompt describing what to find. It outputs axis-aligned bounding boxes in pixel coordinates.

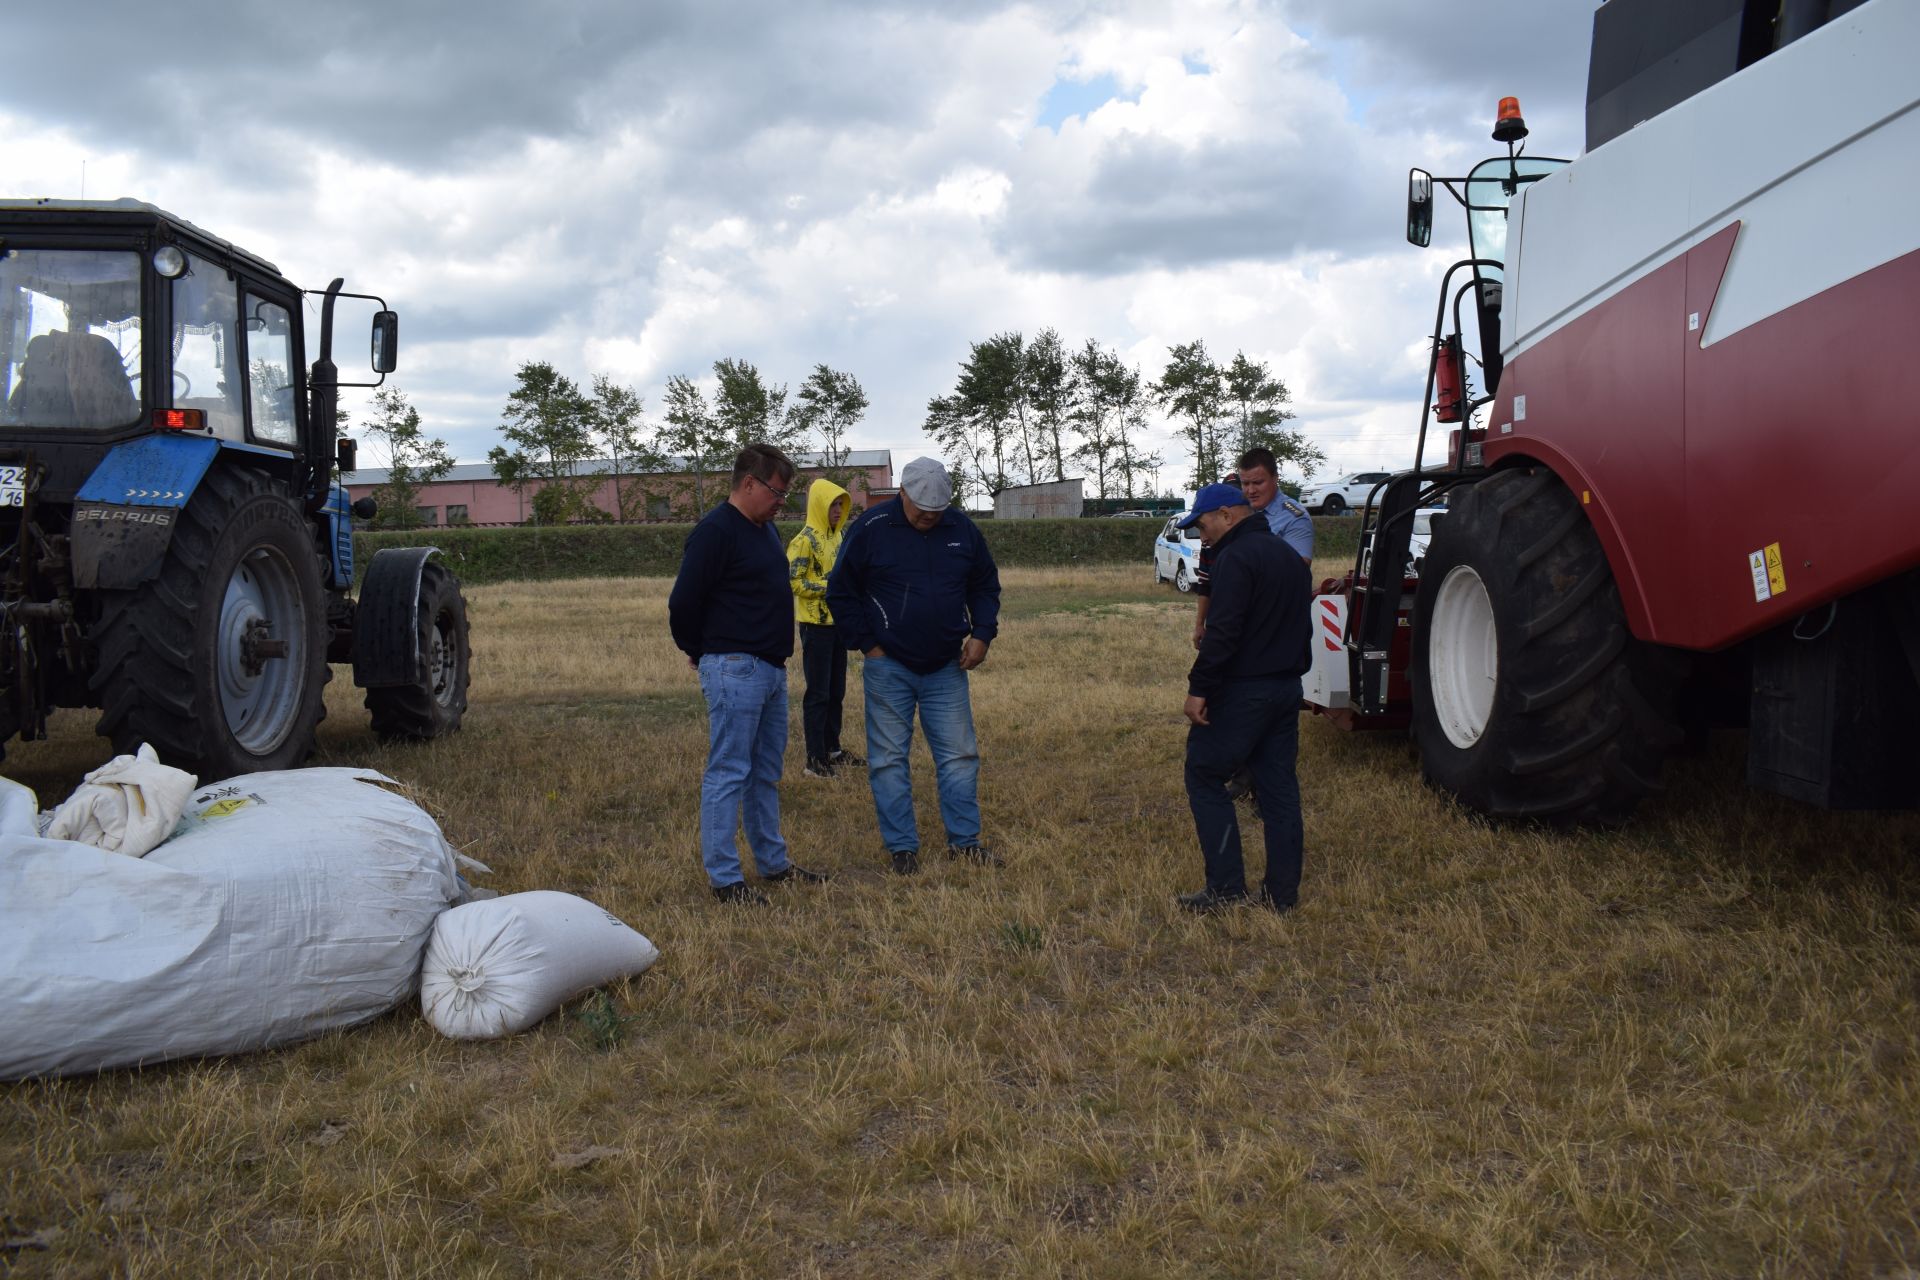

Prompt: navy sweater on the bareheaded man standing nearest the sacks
[666,503,793,666]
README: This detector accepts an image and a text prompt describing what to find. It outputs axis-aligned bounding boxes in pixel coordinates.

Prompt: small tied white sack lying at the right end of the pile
[420,889,660,1040]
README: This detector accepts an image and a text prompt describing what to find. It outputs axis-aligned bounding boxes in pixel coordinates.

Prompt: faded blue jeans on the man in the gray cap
[875,658,979,852]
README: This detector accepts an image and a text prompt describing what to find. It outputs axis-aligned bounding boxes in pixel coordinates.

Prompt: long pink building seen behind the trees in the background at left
[342,449,897,524]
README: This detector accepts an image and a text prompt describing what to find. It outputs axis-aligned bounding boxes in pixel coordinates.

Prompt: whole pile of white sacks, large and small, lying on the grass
[0,747,659,1080]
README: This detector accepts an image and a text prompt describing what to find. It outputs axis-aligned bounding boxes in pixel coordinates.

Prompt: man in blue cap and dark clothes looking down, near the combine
[1179,484,1311,913]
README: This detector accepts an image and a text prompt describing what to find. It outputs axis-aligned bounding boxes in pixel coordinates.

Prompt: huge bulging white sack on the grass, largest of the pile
[0,770,459,1079]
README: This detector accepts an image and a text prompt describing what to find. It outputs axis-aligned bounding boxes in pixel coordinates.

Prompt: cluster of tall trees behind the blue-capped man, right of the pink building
[925,328,1327,497]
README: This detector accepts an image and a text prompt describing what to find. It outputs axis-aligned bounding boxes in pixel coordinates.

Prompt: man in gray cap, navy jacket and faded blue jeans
[828,459,1000,875]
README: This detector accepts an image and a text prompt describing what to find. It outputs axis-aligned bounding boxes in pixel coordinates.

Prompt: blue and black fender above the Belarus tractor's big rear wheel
[71,436,221,591]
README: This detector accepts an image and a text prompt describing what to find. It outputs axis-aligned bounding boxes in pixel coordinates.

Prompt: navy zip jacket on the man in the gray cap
[828,499,1000,676]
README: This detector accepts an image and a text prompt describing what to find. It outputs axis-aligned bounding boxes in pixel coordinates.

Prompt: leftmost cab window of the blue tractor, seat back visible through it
[0,249,140,430]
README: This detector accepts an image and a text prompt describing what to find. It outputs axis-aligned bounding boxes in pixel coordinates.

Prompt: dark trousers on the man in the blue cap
[1187,676,1302,906]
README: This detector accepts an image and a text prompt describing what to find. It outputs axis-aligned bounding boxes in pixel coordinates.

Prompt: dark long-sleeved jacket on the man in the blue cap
[1187,512,1313,699]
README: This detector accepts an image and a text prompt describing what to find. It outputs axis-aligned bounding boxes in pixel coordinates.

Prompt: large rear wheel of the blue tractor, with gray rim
[90,466,332,781]
